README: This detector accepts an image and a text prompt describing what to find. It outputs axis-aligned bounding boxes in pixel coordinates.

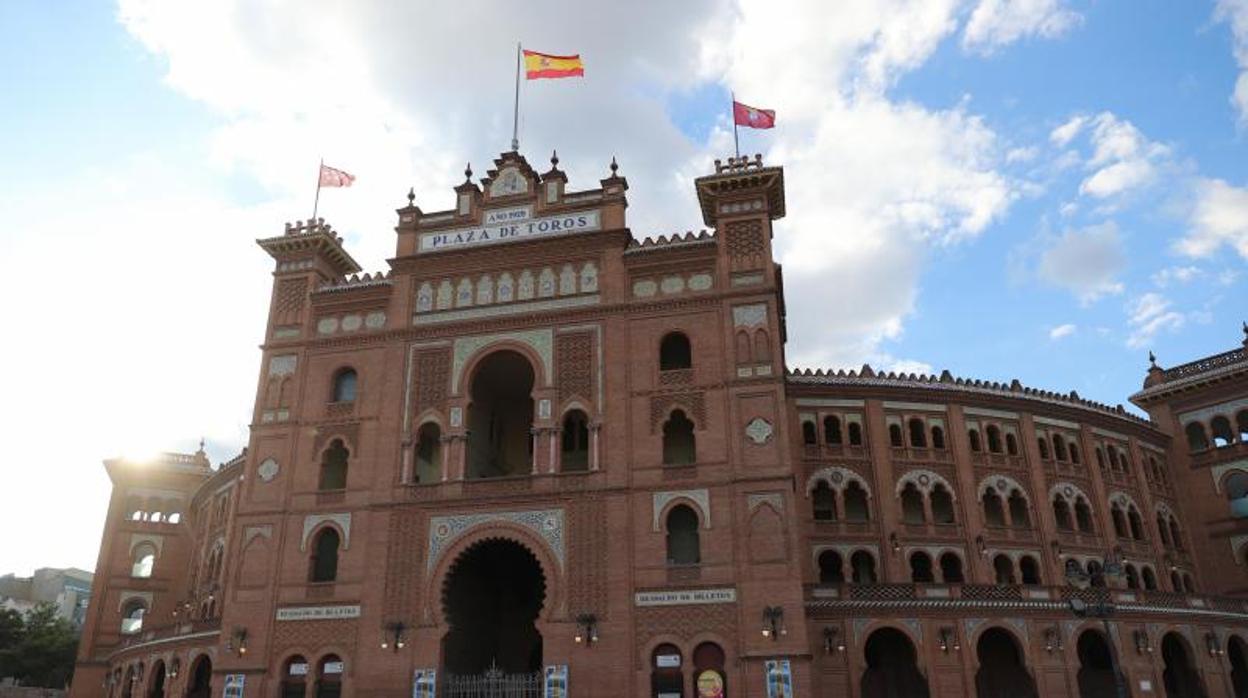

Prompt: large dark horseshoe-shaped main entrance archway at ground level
[442,538,545,676]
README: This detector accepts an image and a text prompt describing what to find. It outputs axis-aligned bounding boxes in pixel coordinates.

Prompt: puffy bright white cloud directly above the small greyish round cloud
[1080,111,1169,199]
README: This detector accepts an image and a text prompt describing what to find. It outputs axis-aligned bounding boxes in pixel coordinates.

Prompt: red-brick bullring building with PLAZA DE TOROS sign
[71,151,1248,698]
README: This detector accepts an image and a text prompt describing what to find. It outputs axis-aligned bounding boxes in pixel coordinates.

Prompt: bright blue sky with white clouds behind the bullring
[0,0,1248,574]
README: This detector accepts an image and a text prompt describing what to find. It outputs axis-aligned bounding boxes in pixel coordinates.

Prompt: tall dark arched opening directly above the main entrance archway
[466,350,534,479]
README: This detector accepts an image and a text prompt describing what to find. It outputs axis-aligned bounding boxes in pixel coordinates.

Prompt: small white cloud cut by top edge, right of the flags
[962,0,1083,54]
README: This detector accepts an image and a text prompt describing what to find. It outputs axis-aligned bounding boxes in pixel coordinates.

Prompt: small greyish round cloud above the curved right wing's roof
[1038,221,1127,305]
